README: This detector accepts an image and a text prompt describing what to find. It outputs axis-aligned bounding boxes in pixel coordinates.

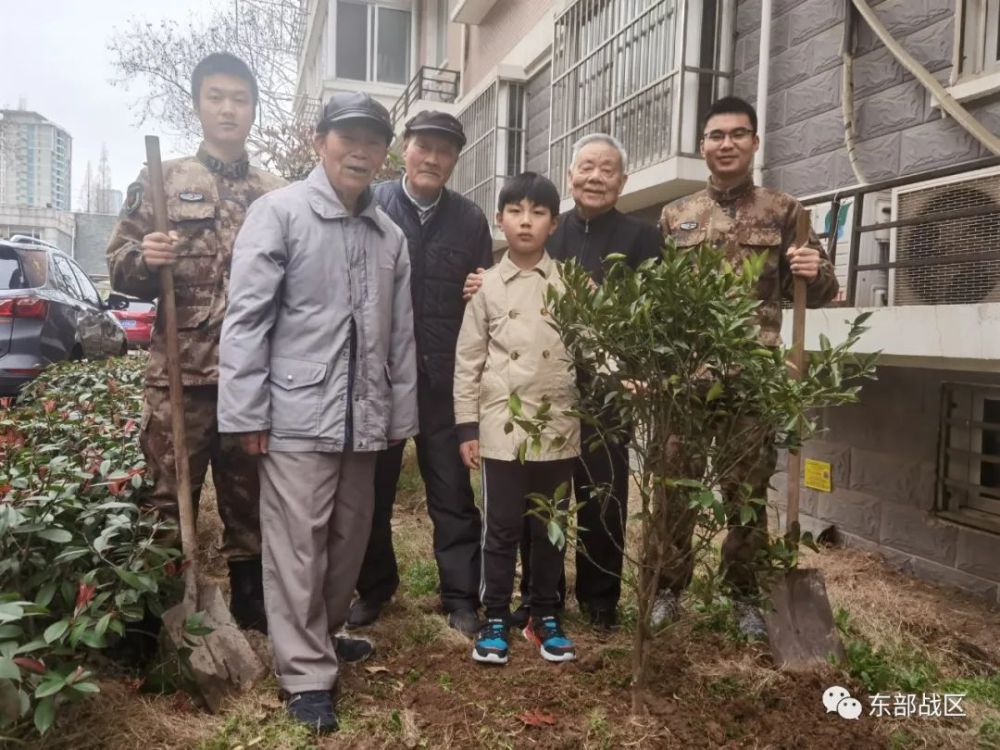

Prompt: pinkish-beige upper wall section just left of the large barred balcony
[462,0,552,92]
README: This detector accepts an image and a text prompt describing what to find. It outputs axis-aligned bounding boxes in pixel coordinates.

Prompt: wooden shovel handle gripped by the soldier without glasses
[146,135,197,583]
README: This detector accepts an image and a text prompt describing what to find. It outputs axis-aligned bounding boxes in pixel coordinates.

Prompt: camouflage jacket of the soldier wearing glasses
[660,175,838,346]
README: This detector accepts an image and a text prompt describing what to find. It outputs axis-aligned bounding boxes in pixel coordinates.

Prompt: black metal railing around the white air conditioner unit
[803,157,1000,307]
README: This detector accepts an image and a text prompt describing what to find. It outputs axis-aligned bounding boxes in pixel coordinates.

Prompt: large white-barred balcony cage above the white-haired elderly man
[549,0,733,192]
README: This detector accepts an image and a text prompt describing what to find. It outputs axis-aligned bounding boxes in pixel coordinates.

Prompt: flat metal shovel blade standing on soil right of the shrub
[763,569,844,672]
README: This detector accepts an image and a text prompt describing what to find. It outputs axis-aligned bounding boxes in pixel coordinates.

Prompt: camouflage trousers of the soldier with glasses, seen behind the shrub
[660,419,777,596]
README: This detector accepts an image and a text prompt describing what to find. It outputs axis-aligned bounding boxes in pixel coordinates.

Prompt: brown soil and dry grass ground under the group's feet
[31,468,1000,750]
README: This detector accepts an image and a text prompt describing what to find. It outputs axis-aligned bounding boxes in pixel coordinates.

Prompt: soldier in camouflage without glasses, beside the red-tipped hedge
[107,54,285,632]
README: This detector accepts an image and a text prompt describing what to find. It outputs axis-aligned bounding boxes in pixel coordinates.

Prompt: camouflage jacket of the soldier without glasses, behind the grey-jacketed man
[107,145,285,386]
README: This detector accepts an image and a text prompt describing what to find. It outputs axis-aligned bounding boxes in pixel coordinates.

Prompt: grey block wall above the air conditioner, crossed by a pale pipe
[734,0,1000,196]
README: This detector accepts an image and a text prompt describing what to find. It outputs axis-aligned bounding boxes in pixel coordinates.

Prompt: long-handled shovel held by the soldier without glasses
[146,136,264,711]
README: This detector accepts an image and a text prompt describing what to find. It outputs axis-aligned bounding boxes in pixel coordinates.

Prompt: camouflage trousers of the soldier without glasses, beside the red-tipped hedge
[139,385,260,560]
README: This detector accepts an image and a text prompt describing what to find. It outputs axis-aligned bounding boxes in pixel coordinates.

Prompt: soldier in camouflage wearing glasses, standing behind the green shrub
[652,97,837,635]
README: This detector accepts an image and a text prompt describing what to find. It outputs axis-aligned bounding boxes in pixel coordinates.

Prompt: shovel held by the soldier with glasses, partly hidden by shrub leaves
[764,211,844,672]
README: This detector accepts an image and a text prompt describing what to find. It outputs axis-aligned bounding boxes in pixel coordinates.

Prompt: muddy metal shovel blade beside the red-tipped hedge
[163,586,265,712]
